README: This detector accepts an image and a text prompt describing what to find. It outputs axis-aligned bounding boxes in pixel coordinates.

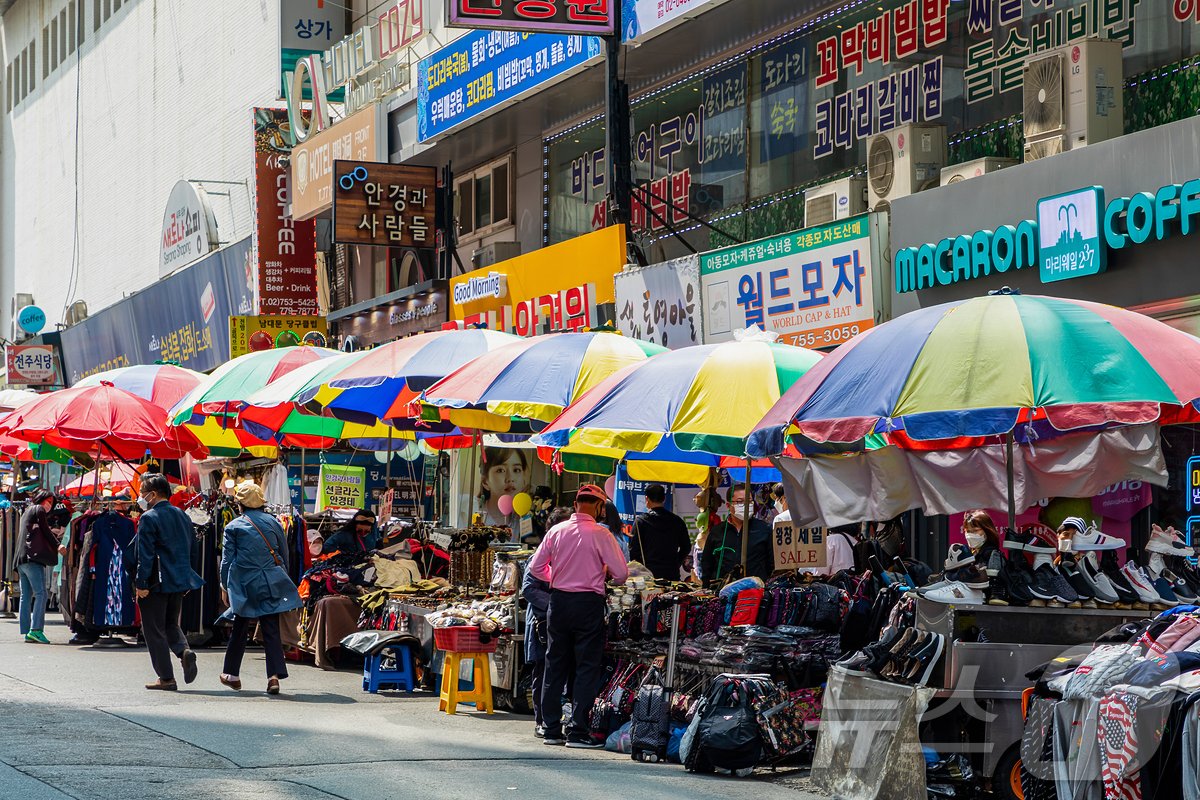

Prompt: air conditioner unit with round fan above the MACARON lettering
[866,125,946,211]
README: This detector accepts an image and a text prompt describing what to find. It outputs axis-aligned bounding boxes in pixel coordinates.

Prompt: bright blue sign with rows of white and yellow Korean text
[416,26,604,142]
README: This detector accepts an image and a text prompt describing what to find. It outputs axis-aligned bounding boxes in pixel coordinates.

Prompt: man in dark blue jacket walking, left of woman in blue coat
[133,473,204,691]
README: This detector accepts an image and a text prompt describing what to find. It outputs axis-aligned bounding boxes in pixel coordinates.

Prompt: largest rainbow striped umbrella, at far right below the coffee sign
[748,294,1200,457]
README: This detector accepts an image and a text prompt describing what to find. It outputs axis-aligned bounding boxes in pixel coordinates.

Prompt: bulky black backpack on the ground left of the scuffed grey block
[684,675,763,775]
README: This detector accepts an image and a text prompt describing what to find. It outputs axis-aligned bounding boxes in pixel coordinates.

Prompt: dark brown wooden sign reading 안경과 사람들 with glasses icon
[334,161,438,247]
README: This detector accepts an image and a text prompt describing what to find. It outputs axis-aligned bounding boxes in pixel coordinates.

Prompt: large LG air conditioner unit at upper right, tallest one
[1021,38,1124,161]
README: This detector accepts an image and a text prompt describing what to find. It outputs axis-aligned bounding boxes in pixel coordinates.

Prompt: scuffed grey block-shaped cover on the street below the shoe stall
[812,666,934,800]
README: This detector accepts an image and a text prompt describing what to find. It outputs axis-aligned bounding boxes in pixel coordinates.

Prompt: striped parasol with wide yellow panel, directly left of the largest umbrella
[533,341,821,457]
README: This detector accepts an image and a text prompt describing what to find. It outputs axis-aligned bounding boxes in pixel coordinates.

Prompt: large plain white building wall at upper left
[0,0,280,335]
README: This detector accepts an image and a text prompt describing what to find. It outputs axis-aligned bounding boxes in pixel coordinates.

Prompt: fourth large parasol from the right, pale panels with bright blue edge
[296,329,517,427]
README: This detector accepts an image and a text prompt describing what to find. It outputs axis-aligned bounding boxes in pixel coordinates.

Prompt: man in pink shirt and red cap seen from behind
[529,483,629,747]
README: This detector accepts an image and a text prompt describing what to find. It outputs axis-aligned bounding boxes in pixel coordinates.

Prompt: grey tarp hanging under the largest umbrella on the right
[772,425,1166,527]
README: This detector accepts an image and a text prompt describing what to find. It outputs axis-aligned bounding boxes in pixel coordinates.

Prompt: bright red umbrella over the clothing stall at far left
[0,383,204,461]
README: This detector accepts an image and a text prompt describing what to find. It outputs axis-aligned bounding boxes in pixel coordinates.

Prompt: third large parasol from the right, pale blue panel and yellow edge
[417,331,666,431]
